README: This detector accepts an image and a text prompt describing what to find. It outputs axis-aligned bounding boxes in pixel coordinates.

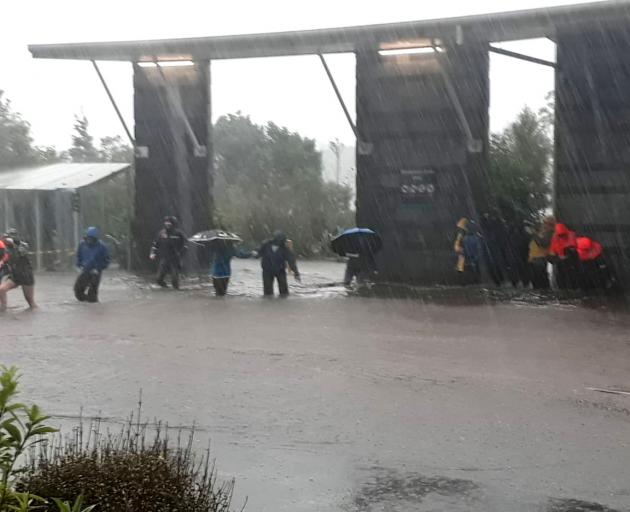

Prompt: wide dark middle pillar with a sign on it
[357,44,489,284]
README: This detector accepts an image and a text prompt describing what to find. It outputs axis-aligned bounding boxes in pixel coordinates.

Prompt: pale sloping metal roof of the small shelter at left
[0,163,131,190]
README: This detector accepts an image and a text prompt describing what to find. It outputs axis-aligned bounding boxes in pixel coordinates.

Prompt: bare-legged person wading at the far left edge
[0,228,37,311]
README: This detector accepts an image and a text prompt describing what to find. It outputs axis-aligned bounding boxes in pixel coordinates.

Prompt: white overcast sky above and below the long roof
[0,0,604,149]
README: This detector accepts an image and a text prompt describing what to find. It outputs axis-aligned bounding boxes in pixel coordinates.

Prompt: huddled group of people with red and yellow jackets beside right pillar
[454,213,614,290]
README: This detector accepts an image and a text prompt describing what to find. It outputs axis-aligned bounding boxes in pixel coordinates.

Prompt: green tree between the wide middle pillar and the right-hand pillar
[488,108,552,219]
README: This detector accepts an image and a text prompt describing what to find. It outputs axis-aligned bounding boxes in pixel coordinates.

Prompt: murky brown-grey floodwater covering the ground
[0,261,630,512]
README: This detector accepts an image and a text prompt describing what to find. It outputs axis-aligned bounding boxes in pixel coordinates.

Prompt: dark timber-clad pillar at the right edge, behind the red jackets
[555,25,630,287]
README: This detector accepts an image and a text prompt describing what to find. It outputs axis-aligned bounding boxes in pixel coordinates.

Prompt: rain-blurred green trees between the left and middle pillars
[214,113,353,255]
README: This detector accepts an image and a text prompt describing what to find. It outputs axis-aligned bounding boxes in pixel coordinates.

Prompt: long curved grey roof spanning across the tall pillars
[29,0,630,61]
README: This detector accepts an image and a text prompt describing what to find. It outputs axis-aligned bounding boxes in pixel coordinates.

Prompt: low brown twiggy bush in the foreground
[19,419,233,512]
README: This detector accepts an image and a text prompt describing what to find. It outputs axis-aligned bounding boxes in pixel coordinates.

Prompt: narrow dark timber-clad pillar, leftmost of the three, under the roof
[133,60,212,269]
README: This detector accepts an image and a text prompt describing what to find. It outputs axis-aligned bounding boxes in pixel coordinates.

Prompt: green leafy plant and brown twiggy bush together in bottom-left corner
[0,366,233,512]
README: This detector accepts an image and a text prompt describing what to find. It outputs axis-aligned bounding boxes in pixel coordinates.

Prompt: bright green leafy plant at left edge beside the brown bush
[0,366,94,512]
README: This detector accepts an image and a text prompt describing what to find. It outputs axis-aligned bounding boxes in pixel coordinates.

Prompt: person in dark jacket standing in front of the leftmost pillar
[149,217,186,290]
